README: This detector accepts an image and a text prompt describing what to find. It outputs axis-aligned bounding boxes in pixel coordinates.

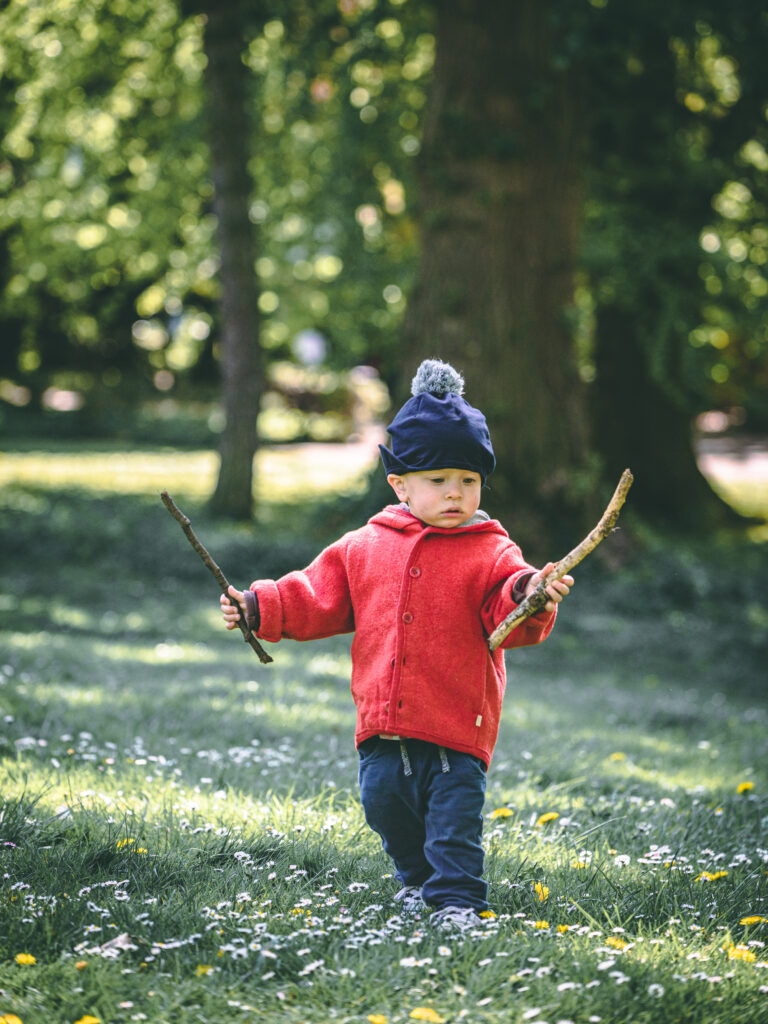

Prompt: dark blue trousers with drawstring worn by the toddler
[359,737,488,911]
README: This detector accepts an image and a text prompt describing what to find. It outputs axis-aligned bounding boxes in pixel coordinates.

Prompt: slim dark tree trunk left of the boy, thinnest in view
[205,0,262,518]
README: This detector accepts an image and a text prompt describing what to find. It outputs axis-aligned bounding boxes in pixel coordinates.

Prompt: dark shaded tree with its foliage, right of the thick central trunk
[584,2,768,530]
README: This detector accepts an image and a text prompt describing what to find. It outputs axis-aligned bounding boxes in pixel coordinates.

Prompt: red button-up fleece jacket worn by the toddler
[251,506,555,764]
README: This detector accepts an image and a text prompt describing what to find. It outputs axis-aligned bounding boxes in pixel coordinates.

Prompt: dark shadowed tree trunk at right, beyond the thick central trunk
[587,16,739,534]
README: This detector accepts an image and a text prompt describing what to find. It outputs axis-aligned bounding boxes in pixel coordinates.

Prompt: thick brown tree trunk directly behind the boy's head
[399,0,602,557]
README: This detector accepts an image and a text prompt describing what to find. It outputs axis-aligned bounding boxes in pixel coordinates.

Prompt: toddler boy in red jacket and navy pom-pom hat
[221,359,573,929]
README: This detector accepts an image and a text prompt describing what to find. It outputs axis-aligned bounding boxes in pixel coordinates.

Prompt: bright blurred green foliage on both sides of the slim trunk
[0,0,433,415]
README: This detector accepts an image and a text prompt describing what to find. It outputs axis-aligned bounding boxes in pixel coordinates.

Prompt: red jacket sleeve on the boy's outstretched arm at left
[251,538,354,642]
